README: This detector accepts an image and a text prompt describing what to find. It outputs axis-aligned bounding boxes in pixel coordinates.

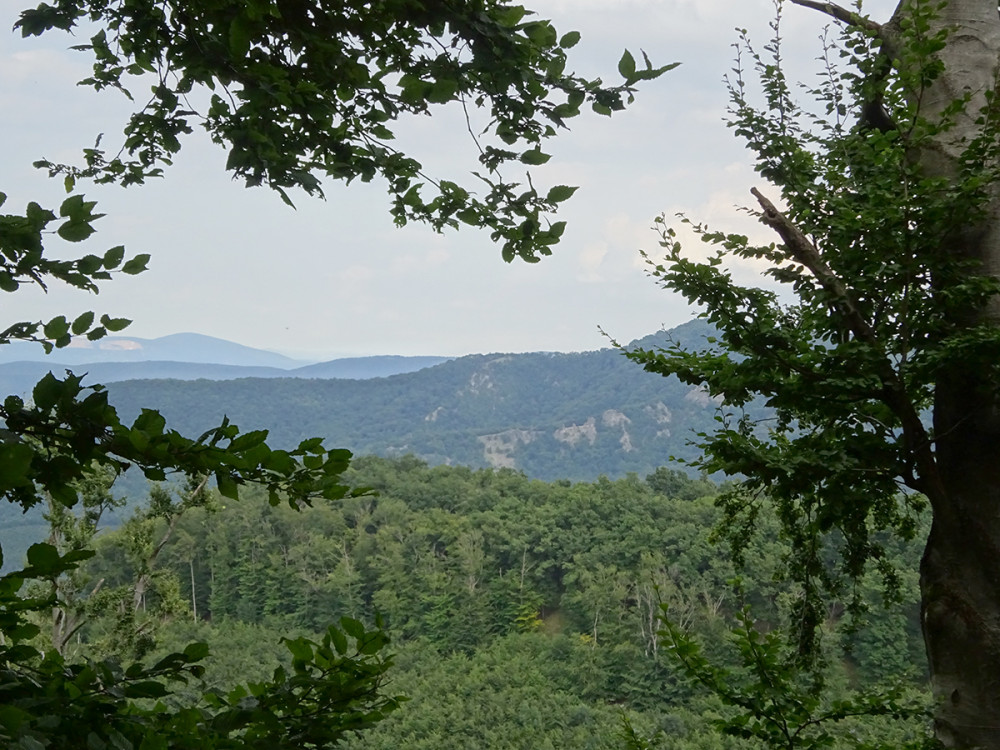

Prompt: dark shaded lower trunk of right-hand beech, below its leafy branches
[920,378,1000,750]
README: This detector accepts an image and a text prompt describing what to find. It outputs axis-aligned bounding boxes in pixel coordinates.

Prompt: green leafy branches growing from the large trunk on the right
[628,2,1000,653]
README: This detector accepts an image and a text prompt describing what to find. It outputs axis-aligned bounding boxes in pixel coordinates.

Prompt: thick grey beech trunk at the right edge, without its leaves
[916,0,1000,750]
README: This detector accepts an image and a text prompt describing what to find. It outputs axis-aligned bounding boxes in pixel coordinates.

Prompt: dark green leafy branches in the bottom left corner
[0,544,398,750]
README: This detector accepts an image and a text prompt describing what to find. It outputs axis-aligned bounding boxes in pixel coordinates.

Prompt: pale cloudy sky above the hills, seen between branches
[0,0,893,360]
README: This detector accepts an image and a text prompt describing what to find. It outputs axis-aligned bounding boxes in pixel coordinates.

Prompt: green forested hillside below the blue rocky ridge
[58,457,924,750]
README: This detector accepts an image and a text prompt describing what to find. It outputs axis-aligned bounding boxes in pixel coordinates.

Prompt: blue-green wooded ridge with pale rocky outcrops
[108,321,736,481]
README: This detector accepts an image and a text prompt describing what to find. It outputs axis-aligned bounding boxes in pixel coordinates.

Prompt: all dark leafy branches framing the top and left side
[0,0,672,749]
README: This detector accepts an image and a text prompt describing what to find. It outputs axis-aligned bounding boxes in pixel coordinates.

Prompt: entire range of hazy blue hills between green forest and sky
[0,320,736,480]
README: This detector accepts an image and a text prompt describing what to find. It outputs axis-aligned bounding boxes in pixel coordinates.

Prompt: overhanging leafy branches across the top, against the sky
[17,0,674,261]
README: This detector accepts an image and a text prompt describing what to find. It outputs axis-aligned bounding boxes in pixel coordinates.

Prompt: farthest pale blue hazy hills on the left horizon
[0,333,449,395]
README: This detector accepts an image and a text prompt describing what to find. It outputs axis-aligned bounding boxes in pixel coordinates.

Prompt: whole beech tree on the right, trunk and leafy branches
[629,0,1000,748]
